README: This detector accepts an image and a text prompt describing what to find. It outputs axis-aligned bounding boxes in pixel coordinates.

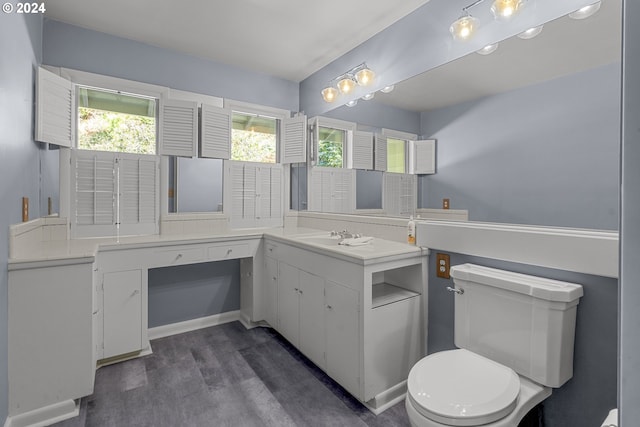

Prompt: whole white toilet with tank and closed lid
[405,264,582,427]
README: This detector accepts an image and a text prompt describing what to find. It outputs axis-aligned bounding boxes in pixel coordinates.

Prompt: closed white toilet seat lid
[407,349,520,426]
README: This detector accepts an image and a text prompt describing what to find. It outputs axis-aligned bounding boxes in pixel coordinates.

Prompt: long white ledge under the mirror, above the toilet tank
[416,221,618,278]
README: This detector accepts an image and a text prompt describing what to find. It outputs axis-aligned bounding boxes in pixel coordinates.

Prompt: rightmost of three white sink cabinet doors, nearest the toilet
[325,281,361,397]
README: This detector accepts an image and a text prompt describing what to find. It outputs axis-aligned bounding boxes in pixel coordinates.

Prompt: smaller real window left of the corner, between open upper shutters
[231,111,279,163]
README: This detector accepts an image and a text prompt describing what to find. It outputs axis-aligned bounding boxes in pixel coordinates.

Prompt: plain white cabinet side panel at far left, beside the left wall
[8,257,95,417]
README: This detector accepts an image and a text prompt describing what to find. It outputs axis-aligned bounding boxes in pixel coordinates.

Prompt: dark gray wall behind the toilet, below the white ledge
[427,250,616,427]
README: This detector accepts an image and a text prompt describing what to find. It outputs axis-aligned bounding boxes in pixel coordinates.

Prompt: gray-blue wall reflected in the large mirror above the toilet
[420,63,621,230]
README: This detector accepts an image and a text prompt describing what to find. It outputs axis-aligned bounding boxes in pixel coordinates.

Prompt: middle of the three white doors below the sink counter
[299,270,326,369]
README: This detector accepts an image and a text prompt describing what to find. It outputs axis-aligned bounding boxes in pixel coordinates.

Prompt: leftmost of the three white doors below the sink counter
[277,262,300,347]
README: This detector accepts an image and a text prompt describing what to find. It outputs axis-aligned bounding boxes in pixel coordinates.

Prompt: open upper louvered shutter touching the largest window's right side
[158,99,198,157]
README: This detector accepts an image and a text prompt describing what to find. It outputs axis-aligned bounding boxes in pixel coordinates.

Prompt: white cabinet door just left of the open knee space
[103,270,142,359]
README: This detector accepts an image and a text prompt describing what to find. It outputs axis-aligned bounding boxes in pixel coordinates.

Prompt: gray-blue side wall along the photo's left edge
[0,13,43,420]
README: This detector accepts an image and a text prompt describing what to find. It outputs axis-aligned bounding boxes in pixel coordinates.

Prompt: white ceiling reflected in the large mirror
[372,0,622,112]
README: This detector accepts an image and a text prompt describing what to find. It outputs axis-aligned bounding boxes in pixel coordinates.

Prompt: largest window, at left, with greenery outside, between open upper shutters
[77,87,156,154]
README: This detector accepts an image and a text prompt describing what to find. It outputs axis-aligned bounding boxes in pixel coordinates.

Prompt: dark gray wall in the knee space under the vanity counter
[149,260,240,328]
